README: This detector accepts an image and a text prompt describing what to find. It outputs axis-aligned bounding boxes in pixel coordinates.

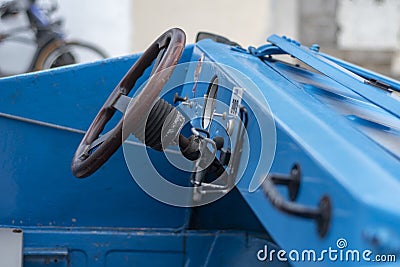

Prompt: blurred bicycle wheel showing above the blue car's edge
[35,41,107,70]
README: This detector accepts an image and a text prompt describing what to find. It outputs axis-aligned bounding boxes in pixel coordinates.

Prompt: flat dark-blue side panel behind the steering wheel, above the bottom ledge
[0,54,189,228]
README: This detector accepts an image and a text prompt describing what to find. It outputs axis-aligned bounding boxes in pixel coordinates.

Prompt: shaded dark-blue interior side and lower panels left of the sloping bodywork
[0,43,280,267]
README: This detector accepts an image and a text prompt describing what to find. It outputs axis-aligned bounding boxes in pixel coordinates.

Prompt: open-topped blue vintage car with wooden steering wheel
[0,28,400,267]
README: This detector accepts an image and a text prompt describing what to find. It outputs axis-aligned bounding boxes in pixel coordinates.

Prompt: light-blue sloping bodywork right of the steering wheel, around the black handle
[192,38,400,266]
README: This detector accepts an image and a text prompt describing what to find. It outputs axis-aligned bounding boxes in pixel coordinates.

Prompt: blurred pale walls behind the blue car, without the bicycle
[0,0,400,78]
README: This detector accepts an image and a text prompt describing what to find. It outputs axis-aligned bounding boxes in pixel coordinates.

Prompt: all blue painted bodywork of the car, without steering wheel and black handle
[0,32,400,267]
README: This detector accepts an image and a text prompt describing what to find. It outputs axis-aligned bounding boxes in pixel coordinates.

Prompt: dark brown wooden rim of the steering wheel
[71,28,186,178]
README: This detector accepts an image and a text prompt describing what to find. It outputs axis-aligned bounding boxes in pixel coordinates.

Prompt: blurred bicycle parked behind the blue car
[0,0,107,77]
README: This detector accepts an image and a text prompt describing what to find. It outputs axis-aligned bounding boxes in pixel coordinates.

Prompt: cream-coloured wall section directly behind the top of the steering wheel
[132,0,270,51]
